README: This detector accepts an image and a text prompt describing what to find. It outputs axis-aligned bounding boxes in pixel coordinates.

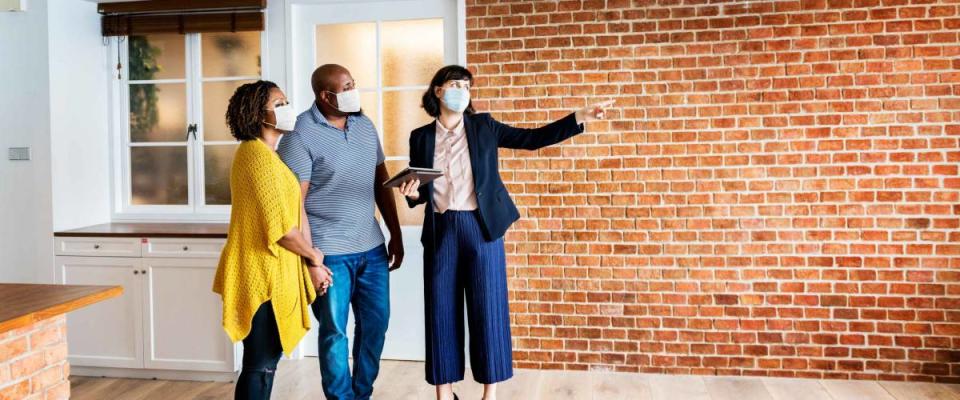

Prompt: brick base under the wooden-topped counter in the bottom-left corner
[0,315,70,400]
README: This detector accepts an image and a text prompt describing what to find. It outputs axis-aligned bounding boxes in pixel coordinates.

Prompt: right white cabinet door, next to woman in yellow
[143,258,235,372]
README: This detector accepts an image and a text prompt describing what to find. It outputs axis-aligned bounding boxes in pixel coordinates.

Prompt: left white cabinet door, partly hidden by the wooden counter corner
[56,257,143,368]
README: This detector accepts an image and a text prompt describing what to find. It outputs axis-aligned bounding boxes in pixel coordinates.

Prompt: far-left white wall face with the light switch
[0,1,53,282]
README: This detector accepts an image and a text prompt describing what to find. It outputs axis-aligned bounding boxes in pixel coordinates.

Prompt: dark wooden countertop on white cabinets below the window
[53,222,229,239]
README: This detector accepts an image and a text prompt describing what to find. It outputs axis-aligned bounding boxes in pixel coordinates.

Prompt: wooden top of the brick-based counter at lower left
[0,283,123,333]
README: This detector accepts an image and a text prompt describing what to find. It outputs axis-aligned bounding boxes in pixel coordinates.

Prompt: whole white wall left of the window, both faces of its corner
[0,0,110,282]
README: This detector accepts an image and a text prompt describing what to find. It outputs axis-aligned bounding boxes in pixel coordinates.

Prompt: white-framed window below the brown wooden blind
[115,32,262,215]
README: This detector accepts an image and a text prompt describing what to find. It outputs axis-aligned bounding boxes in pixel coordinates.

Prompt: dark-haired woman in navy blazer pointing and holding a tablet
[399,65,613,400]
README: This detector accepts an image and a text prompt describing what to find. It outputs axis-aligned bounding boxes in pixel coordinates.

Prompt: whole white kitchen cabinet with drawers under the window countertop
[54,237,240,380]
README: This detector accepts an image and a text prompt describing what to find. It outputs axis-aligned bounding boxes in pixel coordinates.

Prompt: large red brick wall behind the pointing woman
[467,0,960,382]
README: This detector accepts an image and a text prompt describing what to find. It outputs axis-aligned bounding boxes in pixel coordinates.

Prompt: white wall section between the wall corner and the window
[48,0,116,231]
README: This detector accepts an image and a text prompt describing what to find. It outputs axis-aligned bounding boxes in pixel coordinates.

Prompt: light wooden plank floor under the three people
[70,358,960,400]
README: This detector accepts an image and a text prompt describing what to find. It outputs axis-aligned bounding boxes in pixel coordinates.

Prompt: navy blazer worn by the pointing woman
[406,114,583,249]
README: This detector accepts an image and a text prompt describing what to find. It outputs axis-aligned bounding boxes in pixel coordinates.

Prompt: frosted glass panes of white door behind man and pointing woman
[315,18,444,225]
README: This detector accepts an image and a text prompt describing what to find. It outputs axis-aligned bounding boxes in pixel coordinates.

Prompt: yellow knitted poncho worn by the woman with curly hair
[213,140,316,355]
